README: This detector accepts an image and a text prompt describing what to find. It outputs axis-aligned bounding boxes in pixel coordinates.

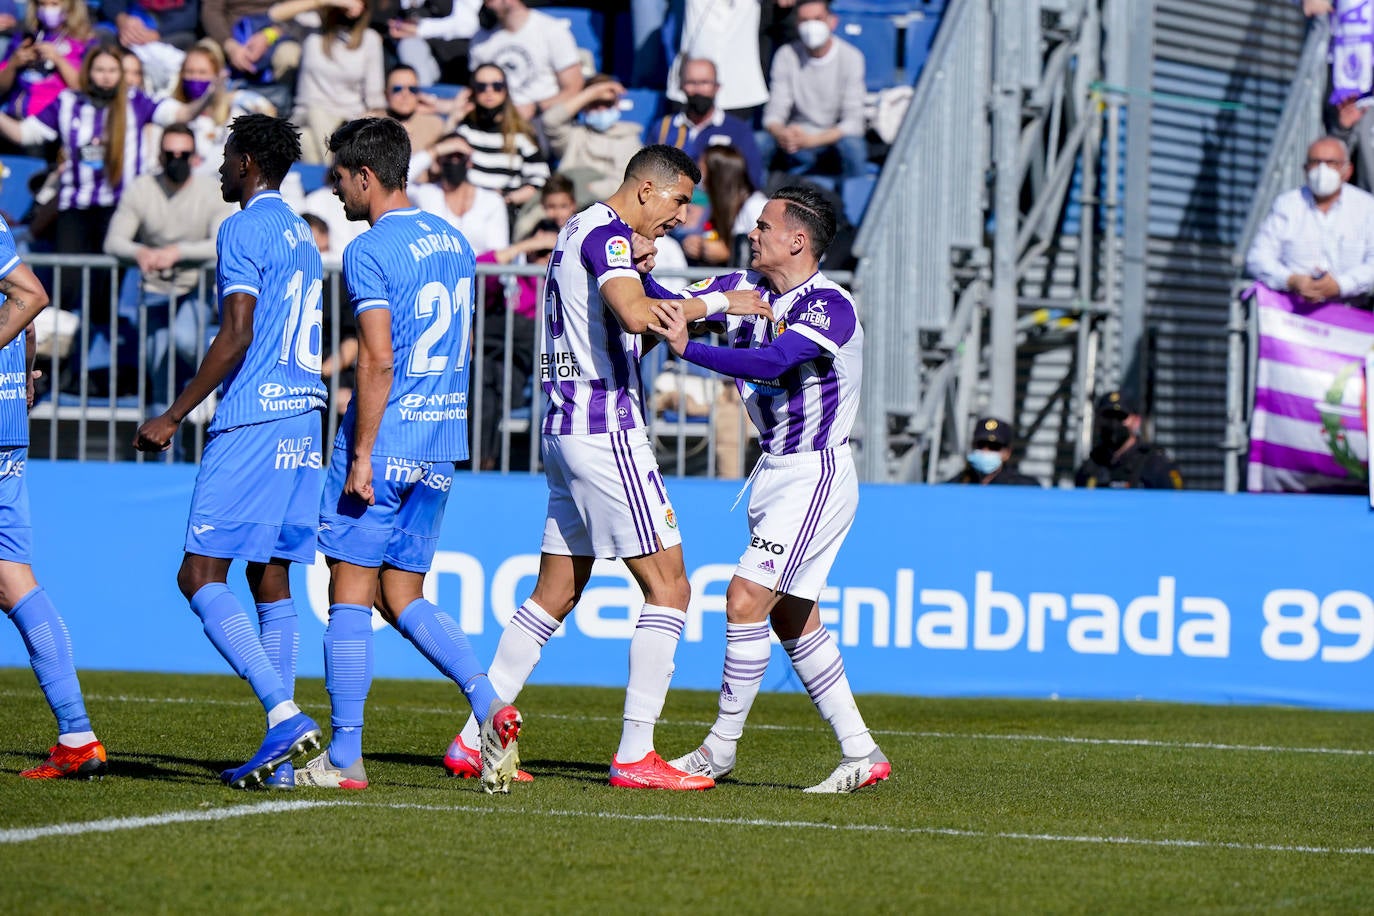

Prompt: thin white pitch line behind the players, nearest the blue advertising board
[0,691,1374,757]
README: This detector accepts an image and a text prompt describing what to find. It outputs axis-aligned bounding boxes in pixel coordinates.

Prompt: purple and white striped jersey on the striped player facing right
[539,203,644,435]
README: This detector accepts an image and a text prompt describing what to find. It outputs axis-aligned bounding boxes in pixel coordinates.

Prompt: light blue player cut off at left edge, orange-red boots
[0,220,106,779]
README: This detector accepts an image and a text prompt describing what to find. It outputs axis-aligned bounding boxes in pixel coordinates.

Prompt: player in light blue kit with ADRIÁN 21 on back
[297,118,521,792]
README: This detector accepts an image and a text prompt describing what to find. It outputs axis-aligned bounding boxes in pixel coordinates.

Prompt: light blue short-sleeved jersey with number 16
[210,191,326,433]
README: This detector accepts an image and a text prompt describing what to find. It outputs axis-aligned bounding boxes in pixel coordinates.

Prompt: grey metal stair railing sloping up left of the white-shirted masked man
[1221,16,1330,493]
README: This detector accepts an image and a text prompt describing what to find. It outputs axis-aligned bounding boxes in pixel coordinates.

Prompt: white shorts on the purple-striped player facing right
[541,428,683,559]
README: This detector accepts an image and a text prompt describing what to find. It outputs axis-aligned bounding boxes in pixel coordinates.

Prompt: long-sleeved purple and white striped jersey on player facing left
[683,271,863,455]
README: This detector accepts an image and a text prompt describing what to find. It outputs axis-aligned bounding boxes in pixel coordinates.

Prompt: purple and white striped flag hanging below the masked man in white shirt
[1246,283,1374,493]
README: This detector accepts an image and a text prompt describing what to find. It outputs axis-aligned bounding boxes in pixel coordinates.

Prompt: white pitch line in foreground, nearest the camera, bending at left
[0,799,1374,856]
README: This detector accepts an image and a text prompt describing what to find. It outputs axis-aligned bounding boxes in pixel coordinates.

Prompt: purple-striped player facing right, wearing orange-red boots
[444,146,768,790]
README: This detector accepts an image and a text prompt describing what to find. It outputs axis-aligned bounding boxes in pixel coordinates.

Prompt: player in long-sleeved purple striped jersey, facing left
[650,187,892,792]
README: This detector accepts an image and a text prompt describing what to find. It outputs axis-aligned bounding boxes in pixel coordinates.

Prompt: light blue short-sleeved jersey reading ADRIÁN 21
[334,209,477,461]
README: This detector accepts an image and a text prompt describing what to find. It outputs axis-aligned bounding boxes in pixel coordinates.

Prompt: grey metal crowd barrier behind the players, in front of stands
[25,253,852,478]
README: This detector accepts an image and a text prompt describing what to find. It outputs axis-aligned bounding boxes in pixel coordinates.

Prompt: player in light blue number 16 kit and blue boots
[135,114,324,788]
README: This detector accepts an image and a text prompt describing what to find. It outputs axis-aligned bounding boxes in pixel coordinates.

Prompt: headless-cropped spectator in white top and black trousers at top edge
[372,0,482,85]
